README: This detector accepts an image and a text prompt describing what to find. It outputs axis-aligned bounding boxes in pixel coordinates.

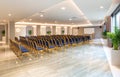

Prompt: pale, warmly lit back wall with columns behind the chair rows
[15,25,102,38]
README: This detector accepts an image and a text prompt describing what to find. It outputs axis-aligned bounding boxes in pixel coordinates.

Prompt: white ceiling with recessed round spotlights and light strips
[0,0,119,25]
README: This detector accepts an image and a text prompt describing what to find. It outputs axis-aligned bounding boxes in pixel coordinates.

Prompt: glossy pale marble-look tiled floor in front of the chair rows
[0,40,112,77]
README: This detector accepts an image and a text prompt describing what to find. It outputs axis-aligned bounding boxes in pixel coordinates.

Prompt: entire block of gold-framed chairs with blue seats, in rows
[10,35,90,57]
